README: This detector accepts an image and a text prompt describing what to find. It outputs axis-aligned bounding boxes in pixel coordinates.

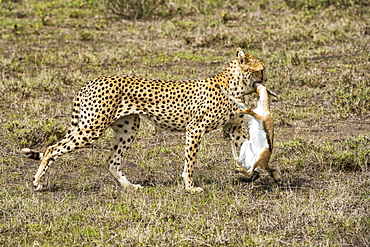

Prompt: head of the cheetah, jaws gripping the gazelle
[235,48,277,97]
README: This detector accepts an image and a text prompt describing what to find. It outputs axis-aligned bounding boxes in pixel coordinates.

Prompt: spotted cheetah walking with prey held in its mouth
[23,48,266,194]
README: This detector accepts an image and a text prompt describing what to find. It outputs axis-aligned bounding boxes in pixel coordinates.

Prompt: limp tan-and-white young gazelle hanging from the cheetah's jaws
[214,82,280,181]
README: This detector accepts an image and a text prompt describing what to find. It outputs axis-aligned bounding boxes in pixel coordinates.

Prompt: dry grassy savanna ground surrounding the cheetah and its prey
[0,0,370,246]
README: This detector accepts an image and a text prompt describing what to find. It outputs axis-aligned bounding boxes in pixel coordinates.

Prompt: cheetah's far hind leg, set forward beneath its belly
[109,115,141,189]
